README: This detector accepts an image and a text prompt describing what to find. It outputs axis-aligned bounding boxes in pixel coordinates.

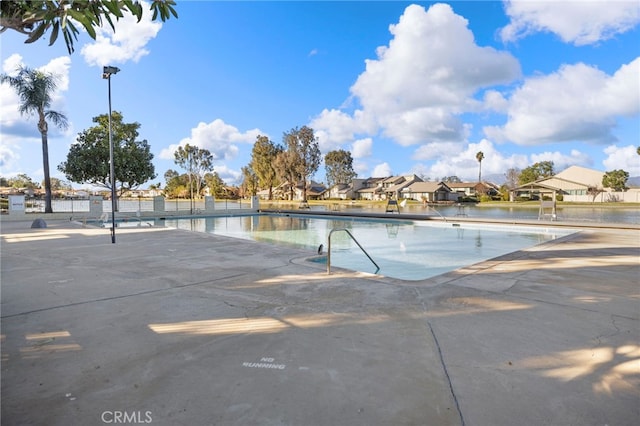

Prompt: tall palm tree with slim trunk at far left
[0,66,68,213]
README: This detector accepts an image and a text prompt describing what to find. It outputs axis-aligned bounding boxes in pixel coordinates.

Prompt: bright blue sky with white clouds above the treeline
[0,0,640,187]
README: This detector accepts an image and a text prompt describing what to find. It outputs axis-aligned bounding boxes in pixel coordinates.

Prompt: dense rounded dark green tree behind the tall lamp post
[58,111,156,195]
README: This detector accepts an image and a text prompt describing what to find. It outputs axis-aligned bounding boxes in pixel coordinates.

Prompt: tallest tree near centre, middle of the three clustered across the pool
[283,126,322,201]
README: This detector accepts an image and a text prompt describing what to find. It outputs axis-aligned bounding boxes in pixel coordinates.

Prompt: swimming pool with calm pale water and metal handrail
[163,214,575,280]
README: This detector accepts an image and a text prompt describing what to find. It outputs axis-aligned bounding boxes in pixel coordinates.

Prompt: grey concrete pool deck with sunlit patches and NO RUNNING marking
[1,220,640,426]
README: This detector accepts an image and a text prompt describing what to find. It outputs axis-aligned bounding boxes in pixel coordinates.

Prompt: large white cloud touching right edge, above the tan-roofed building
[484,58,640,145]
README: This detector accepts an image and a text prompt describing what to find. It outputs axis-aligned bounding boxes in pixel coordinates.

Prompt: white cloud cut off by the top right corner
[500,0,640,46]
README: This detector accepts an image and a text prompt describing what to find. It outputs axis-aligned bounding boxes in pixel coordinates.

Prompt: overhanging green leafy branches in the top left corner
[0,0,178,54]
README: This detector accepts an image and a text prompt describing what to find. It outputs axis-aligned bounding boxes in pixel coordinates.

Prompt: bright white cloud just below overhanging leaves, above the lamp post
[79,1,162,66]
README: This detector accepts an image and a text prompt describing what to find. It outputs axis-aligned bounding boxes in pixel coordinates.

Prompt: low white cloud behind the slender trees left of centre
[159,118,267,161]
